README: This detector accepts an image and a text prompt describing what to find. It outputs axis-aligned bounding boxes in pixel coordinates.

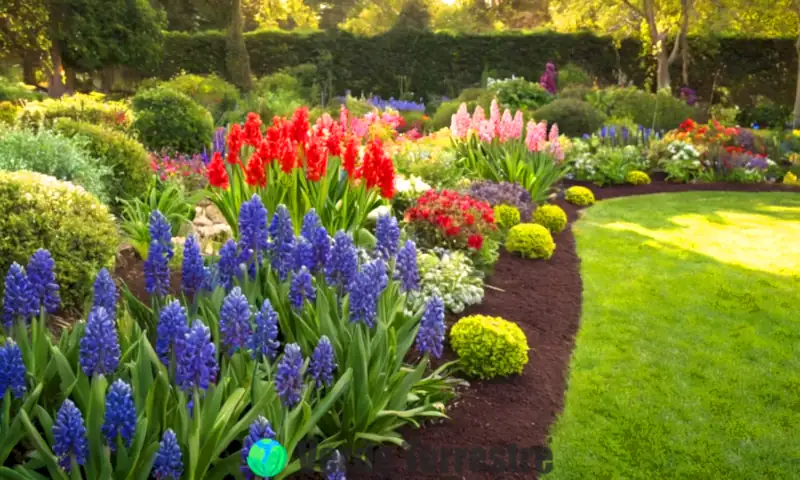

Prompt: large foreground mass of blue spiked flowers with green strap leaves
[0,196,459,479]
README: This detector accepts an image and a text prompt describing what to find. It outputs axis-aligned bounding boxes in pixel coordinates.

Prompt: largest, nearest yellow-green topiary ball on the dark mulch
[450,315,528,378]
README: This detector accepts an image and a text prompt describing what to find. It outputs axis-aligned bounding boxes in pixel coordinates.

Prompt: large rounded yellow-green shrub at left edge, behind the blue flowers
[0,171,119,309]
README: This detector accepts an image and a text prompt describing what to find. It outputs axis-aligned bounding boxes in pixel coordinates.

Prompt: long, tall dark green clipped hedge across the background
[140,30,797,109]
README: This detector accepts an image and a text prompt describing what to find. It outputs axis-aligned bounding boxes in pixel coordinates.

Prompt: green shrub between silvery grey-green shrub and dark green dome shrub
[55,118,153,202]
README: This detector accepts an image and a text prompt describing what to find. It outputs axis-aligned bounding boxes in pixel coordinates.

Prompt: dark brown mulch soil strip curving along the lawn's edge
[109,179,800,480]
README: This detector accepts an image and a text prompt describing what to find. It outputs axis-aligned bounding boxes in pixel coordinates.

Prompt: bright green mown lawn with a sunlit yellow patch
[547,192,800,480]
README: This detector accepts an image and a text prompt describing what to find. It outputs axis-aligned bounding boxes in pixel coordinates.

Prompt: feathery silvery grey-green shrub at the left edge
[0,129,111,201]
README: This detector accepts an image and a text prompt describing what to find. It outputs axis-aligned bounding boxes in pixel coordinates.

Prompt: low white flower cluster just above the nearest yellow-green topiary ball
[412,251,483,313]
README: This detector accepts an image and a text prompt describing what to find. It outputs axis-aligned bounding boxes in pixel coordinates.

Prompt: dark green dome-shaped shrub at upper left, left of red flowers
[133,87,214,153]
